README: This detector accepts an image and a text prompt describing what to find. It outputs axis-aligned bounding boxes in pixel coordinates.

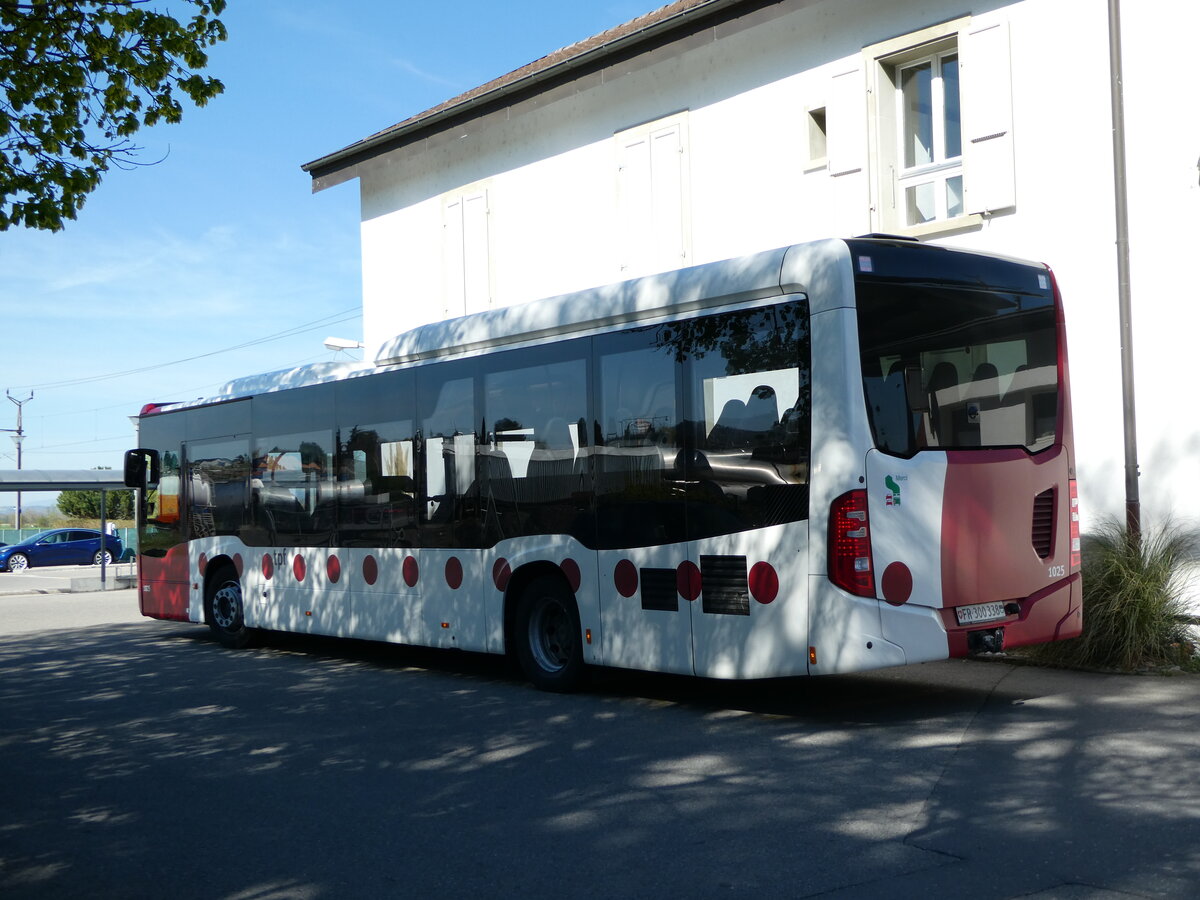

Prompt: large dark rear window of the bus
[856,264,1058,456]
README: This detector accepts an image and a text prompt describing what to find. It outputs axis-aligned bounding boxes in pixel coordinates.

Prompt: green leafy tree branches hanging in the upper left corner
[0,0,226,230]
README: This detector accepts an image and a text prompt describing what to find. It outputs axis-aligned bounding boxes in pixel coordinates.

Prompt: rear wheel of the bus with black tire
[514,575,586,694]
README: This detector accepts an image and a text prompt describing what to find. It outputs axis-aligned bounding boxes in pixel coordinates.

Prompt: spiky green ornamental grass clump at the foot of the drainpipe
[1028,522,1196,671]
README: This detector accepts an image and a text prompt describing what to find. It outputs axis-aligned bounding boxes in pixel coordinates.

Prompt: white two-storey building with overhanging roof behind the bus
[305,0,1200,542]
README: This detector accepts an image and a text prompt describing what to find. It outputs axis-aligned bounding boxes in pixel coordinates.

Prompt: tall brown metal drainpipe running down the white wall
[1109,0,1141,541]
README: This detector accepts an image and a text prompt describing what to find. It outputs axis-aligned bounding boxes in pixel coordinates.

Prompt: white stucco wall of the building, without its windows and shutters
[350,0,1200,540]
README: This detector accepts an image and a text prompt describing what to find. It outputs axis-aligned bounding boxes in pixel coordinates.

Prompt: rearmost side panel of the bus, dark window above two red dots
[679,300,811,678]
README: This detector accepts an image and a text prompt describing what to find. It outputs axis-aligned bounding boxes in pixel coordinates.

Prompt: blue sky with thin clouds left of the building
[0,0,659,511]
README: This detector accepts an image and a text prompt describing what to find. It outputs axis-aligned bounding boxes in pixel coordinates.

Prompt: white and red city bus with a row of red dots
[126,238,1082,690]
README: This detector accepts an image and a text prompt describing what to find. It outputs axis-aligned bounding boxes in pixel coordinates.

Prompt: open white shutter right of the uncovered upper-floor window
[960,17,1016,214]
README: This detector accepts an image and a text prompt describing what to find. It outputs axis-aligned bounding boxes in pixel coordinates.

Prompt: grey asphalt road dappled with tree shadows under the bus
[0,590,1200,900]
